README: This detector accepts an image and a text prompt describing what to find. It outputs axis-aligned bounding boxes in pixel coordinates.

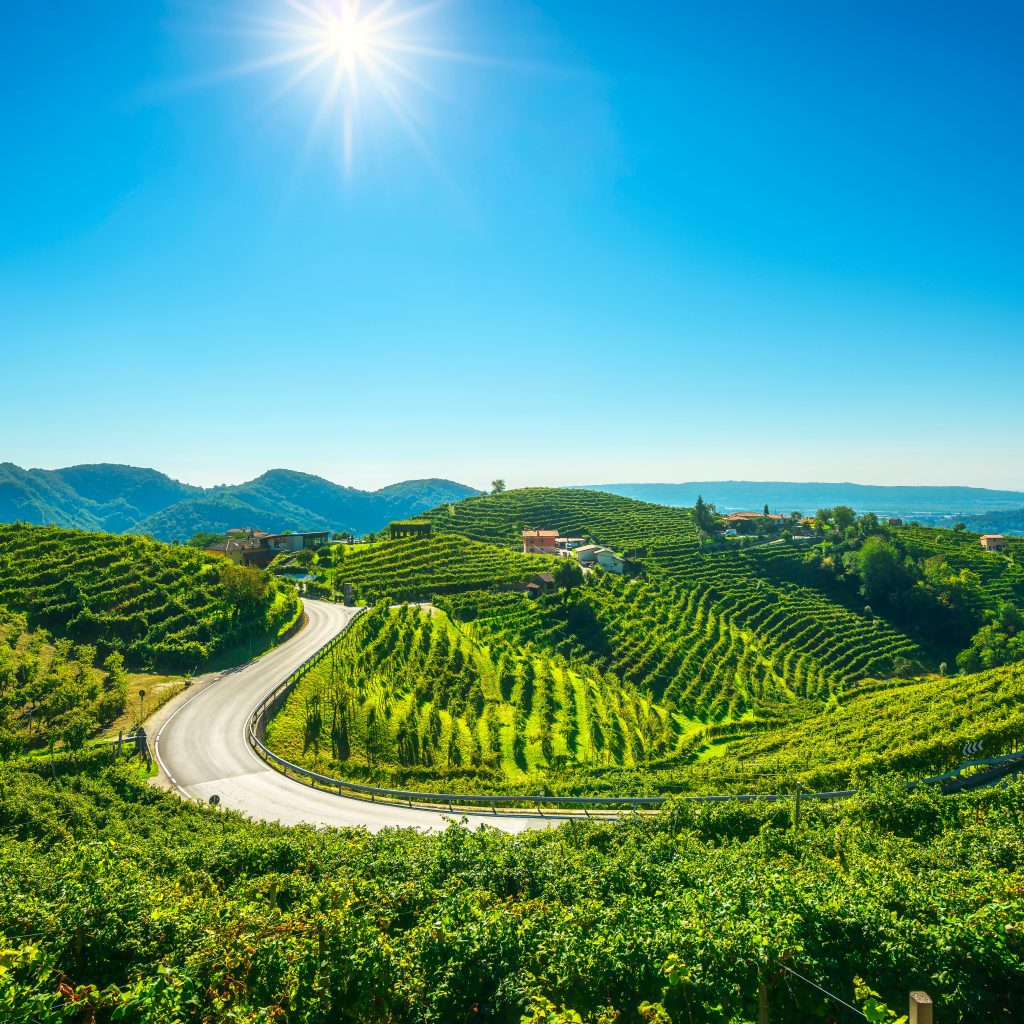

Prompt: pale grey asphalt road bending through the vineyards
[154,600,560,833]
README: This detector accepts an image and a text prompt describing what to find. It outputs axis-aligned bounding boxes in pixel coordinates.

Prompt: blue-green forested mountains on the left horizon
[0,463,478,541]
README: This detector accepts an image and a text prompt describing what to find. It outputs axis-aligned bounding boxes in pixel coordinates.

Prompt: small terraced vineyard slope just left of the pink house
[326,535,558,604]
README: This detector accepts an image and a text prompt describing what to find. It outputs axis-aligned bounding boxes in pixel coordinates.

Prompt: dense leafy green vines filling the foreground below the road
[0,760,1024,1024]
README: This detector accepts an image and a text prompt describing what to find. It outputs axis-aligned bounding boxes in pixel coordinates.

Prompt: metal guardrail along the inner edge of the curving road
[246,612,1024,812]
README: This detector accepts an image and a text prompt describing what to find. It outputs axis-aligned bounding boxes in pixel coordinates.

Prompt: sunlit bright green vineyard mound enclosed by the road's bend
[267,597,690,793]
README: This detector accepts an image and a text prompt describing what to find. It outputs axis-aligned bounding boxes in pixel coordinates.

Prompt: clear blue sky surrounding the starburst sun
[0,0,1024,488]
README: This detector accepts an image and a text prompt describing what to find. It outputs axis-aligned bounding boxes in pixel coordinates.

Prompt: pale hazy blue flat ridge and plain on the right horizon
[587,480,1024,532]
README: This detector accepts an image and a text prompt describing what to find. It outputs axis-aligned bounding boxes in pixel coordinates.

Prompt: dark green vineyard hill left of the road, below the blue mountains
[0,523,298,669]
